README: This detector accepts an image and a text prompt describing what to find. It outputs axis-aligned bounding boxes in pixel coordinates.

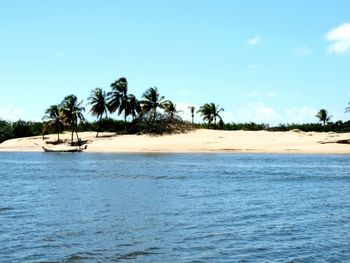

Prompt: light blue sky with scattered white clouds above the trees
[0,0,350,125]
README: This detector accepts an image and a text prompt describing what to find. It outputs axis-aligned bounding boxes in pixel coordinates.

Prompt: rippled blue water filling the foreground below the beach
[0,153,350,262]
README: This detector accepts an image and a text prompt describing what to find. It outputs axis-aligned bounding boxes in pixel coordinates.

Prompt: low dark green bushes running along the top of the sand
[0,118,350,143]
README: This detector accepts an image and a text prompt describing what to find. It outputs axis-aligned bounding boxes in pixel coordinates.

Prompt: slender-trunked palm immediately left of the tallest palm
[88,88,108,137]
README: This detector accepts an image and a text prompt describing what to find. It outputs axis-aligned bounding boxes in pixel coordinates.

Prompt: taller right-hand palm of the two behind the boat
[61,95,85,144]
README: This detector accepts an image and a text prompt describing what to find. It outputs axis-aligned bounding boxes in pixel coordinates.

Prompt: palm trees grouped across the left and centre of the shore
[43,78,223,144]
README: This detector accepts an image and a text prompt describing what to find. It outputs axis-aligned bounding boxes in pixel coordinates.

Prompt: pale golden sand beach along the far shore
[0,129,350,154]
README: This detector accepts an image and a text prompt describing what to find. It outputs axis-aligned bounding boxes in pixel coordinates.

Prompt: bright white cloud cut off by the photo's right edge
[326,23,350,54]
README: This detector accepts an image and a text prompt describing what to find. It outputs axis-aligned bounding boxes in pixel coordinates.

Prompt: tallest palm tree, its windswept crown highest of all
[107,78,128,125]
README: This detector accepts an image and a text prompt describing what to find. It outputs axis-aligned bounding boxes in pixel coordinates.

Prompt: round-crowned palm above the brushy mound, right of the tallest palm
[141,87,168,121]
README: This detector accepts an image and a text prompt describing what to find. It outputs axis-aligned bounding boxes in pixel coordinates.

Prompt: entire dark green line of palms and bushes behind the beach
[0,77,350,144]
